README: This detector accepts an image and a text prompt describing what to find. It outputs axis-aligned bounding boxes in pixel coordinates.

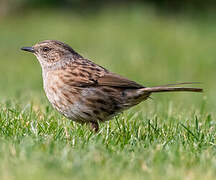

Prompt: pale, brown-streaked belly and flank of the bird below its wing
[45,83,150,123]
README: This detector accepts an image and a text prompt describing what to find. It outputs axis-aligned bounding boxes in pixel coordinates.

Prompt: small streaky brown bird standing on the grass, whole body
[21,40,202,131]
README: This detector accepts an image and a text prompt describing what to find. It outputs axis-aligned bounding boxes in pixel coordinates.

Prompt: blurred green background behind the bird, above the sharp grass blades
[0,0,216,108]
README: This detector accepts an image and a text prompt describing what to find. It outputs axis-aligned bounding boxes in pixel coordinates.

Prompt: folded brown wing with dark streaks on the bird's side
[64,59,143,88]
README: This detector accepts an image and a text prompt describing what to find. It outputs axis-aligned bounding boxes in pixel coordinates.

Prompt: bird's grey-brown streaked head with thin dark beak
[21,40,81,68]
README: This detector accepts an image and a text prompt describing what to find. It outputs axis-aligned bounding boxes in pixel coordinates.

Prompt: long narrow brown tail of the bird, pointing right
[143,83,203,93]
